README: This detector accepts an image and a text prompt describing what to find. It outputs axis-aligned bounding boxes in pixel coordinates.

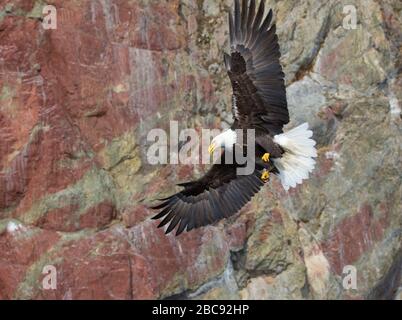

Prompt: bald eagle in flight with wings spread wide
[153,0,317,235]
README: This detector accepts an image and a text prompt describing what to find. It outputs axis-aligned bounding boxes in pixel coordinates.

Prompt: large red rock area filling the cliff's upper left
[0,1,196,217]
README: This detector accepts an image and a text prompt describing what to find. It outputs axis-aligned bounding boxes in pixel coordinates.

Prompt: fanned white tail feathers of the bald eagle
[273,123,317,191]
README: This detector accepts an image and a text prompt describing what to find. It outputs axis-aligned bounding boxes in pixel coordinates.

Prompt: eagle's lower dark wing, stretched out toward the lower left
[153,152,264,235]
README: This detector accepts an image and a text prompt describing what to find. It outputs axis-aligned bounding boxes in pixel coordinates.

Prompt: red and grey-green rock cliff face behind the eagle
[0,0,402,299]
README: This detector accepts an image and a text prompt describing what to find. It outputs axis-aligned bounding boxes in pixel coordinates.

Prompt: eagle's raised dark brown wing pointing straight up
[224,0,289,134]
